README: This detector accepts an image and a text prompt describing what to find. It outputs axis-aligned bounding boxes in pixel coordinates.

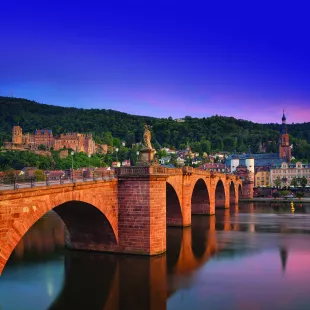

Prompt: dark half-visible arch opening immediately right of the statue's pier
[166,182,183,226]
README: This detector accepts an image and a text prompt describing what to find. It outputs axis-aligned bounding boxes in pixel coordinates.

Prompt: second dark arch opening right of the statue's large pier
[191,179,210,214]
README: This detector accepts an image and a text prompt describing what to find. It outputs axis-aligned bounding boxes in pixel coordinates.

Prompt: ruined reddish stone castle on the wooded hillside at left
[4,126,108,155]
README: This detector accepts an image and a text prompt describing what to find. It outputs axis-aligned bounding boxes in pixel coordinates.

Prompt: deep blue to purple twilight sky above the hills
[0,0,310,123]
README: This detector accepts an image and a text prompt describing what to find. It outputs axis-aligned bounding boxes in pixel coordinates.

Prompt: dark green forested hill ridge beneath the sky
[0,97,310,160]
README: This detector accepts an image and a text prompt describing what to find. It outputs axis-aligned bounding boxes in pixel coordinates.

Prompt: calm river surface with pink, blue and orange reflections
[0,203,310,310]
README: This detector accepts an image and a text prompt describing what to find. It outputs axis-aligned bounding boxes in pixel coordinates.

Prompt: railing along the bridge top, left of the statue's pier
[0,170,115,190]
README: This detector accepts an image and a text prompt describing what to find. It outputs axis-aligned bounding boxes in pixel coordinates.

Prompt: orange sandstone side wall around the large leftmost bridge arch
[0,181,118,273]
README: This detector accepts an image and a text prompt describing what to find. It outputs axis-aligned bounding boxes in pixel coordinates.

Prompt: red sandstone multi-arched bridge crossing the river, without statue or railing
[0,166,242,273]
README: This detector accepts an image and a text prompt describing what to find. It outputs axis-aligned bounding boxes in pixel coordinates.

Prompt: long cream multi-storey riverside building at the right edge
[270,162,310,187]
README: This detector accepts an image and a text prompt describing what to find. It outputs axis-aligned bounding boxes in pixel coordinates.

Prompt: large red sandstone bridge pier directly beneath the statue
[118,166,167,255]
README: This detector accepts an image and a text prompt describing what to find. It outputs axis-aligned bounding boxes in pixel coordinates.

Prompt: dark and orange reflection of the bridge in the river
[4,203,310,310]
